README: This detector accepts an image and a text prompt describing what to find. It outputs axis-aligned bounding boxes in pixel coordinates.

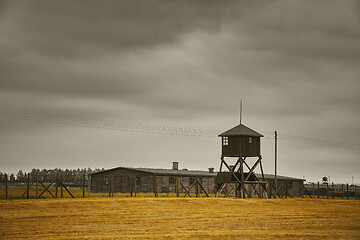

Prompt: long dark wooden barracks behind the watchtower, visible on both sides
[90,162,304,196]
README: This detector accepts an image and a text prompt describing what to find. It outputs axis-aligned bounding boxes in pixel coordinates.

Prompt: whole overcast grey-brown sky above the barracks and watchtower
[0,0,360,183]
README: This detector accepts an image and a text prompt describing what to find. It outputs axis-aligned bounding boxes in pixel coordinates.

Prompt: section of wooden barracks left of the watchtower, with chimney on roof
[90,162,216,196]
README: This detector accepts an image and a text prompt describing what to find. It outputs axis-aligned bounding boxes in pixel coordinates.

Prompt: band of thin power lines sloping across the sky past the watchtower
[0,108,360,151]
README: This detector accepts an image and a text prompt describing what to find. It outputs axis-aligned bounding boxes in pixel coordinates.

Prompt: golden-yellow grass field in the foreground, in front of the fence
[0,197,360,239]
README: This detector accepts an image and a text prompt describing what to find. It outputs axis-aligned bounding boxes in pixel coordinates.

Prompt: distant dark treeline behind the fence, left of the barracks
[0,168,105,183]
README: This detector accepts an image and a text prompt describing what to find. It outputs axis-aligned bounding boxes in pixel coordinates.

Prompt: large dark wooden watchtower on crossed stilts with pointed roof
[216,123,266,198]
